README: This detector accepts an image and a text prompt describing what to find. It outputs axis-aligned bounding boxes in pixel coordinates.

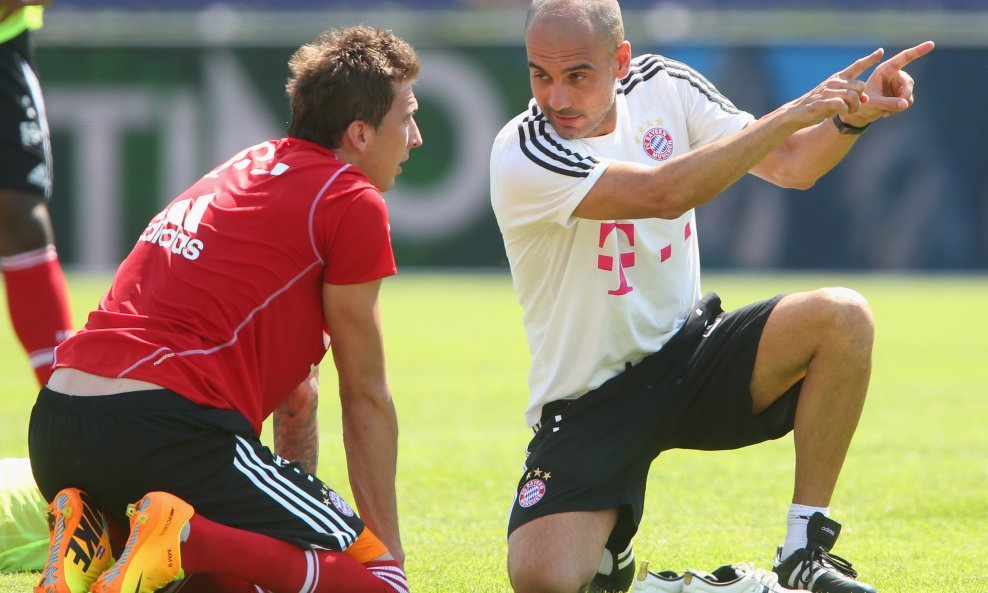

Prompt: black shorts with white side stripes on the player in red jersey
[28,389,364,551]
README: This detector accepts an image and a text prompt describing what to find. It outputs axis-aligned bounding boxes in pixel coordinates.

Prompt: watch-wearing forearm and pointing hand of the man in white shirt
[751,41,934,189]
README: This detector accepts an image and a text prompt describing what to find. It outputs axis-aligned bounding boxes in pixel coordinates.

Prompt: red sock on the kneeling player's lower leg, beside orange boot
[181,515,407,593]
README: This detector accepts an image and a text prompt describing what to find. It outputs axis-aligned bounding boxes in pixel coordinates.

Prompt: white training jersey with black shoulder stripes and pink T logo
[491,55,754,426]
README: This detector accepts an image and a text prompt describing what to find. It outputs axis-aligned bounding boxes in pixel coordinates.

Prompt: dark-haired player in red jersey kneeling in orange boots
[29,26,422,593]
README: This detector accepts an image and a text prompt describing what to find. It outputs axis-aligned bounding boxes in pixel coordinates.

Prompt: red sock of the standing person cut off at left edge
[0,245,72,386]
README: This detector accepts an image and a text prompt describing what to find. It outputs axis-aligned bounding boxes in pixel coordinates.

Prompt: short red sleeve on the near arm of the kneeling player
[317,185,398,284]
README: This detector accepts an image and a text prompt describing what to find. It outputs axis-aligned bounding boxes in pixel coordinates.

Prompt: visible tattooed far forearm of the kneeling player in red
[273,368,319,474]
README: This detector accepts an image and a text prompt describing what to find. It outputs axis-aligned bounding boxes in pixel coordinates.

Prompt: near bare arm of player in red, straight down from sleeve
[323,280,405,564]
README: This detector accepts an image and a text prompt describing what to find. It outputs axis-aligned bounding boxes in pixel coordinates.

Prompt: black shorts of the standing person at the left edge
[0,32,52,198]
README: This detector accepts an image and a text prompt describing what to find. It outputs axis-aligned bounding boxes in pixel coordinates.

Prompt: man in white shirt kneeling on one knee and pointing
[491,0,933,593]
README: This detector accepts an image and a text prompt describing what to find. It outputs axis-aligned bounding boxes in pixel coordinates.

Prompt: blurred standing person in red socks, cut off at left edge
[0,0,72,386]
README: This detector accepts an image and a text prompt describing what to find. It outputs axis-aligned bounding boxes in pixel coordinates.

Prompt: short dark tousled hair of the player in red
[285,25,419,149]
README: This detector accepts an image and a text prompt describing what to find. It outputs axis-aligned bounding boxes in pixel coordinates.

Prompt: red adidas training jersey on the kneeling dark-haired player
[55,138,397,434]
